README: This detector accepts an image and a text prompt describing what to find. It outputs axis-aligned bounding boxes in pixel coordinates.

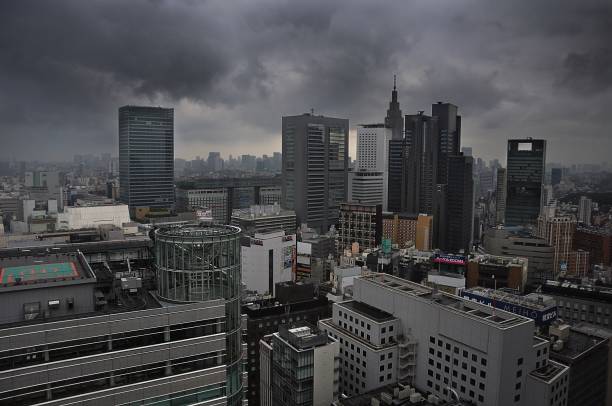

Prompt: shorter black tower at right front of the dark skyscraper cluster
[443,155,474,253]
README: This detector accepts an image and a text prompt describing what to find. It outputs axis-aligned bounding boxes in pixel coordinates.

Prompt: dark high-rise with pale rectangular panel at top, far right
[505,138,546,226]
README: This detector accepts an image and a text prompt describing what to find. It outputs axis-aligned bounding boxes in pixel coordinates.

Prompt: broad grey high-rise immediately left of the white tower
[282,113,349,232]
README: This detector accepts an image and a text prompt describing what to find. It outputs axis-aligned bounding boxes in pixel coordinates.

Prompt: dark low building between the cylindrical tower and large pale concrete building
[242,283,331,405]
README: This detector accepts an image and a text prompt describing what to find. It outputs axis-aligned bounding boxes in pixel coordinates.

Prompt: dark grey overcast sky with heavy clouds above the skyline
[0,0,612,163]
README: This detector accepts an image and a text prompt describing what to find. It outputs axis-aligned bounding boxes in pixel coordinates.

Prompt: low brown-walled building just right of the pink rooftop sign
[467,255,528,292]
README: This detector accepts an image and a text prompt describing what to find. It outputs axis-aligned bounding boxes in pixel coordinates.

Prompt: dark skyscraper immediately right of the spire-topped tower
[402,111,439,214]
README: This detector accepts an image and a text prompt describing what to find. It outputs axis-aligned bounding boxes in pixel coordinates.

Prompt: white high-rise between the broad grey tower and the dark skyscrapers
[349,124,391,211]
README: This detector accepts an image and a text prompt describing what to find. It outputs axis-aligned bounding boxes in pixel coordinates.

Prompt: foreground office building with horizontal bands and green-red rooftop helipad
[0,247,239,406]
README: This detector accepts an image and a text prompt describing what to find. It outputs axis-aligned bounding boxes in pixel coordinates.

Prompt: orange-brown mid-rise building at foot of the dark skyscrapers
[383,213,433,251]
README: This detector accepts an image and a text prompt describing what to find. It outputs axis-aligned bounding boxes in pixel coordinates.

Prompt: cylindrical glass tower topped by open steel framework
[155,224,242,405]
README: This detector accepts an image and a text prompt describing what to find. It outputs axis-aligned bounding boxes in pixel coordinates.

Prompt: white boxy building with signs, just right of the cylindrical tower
[240,231,295,295]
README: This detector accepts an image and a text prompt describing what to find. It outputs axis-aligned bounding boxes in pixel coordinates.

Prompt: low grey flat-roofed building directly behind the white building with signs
[232,203,296,236]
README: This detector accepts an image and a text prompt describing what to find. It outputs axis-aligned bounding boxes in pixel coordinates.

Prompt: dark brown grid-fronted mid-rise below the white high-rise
[336,202,383,252]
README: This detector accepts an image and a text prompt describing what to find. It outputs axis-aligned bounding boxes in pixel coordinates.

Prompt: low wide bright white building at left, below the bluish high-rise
[57,204,131,230]
